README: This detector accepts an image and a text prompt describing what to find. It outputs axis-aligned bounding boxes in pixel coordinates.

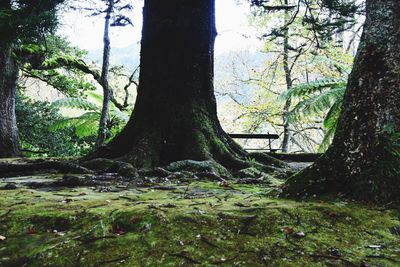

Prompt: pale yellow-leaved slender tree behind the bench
[225,0,353,152]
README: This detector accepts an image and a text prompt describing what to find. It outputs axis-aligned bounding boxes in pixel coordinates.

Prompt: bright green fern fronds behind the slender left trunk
[49,92,129,138]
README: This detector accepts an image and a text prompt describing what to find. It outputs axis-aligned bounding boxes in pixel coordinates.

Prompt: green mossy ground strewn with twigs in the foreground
[0,177,400,266]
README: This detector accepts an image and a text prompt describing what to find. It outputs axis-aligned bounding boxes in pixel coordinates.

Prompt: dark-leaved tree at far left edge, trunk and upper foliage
[0,0,62,157]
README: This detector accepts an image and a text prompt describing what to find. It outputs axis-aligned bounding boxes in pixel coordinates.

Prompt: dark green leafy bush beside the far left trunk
[16,93,94,157]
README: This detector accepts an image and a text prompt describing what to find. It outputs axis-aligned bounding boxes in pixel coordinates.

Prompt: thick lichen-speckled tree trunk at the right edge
[284,0,400,201]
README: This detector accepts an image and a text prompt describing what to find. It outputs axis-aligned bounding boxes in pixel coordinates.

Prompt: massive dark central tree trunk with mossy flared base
[93,0,253,168]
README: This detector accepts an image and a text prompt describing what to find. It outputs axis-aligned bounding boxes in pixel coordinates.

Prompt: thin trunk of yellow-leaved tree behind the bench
[282,0,292,152]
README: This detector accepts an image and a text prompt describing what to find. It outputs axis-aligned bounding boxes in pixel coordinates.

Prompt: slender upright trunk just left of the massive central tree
[97,0,114,147]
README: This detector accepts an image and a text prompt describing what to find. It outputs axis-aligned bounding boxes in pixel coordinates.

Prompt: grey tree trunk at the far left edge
[0,44,19,158]
